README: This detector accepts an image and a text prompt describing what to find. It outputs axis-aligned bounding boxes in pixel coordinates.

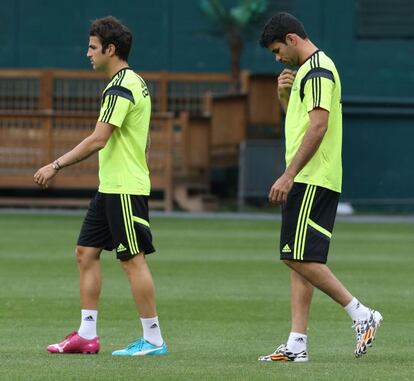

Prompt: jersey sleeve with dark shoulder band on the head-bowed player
[301,67,335,112]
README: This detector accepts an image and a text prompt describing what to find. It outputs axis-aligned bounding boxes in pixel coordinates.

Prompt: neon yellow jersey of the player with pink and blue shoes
[98,68,151,195]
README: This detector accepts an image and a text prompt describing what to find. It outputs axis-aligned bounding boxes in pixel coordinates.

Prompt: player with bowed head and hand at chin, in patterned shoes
[259,12,382,362]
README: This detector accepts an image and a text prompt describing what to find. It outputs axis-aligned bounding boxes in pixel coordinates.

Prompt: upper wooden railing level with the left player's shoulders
[0,69,230,115]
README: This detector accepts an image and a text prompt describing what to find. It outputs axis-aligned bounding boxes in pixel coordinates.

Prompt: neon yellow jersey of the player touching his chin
[285,50,342,192]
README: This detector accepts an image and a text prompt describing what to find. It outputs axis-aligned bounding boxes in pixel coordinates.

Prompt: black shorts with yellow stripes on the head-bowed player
[280,183,339,263]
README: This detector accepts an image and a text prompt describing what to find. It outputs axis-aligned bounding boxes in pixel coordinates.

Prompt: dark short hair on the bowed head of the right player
[260,12,308,48]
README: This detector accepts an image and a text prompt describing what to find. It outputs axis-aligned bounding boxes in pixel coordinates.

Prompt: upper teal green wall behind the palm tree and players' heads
[4,0,414,97]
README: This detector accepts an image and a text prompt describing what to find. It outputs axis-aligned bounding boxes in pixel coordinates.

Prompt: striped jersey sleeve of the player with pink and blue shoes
[98,86,135,127]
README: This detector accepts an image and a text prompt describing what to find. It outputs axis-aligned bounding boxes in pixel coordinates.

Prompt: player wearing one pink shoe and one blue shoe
[34,16,167,356]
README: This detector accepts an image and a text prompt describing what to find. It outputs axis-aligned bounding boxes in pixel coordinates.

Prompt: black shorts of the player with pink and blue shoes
[78,192,155,261]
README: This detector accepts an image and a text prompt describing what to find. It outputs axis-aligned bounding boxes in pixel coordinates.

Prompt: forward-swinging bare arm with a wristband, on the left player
[34,121,116,188]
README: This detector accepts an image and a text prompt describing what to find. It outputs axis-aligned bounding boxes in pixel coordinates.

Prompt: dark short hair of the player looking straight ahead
[89,16,132,61]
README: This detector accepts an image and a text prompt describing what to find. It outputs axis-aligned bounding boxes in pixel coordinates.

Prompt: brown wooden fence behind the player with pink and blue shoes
[0,69,230,210]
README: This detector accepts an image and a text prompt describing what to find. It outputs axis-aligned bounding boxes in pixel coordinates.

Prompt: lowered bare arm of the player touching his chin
[269,108,329,204]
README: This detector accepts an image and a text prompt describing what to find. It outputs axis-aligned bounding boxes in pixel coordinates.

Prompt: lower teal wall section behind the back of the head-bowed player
[343,103,414,211]
